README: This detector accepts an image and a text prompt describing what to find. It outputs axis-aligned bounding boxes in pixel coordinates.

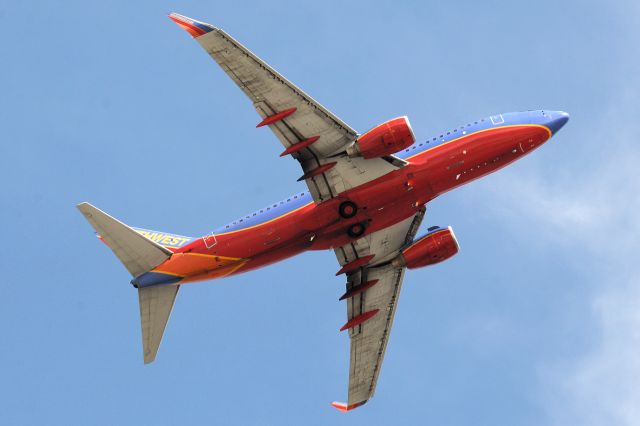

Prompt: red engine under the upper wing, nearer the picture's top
[347,116,416,159]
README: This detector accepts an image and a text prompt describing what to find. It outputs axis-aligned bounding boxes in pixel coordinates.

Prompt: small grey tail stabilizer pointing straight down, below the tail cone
[138,285,180,364]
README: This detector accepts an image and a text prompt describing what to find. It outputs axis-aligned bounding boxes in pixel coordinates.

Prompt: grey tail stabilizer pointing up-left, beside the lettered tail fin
[77,203,171,277]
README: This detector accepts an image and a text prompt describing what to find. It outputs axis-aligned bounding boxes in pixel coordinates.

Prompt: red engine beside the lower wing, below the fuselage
[392,226,460,269]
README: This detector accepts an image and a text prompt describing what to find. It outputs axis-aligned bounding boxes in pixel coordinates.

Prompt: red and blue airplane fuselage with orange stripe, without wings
[132,111,568,287]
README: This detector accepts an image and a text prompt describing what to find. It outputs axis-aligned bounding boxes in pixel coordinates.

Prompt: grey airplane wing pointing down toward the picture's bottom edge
[332,209,425,411]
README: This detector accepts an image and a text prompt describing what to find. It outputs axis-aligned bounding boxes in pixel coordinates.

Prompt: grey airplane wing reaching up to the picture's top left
[169,13,404,203]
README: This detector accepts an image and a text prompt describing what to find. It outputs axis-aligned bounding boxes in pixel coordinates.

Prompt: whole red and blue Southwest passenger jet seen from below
[77,13,569,412]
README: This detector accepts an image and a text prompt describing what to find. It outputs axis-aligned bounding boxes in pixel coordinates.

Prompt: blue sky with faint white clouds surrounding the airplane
[0,0,640,425]
